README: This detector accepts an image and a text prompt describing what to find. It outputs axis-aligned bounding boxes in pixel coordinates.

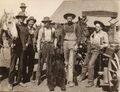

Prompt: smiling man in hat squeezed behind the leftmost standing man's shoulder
[24,16,36,81]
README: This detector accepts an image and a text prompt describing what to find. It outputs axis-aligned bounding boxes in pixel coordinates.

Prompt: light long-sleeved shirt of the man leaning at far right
[90,30,109,48]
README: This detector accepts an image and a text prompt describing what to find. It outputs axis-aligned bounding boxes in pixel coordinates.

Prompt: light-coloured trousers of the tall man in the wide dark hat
[63,41,76,82]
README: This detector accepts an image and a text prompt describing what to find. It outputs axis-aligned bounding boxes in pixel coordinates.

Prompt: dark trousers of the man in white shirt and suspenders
[37,42,55,88]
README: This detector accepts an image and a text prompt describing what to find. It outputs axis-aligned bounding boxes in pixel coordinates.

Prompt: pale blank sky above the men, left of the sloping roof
[0,0,63,23]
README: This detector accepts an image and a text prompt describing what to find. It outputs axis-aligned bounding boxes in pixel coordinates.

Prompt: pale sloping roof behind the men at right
[51,0,119,26]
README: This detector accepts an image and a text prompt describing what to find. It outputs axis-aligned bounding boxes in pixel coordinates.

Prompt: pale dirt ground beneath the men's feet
[0,79,106,92]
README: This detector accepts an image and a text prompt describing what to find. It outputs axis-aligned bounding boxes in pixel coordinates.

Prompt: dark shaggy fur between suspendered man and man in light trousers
[52,48,66,87]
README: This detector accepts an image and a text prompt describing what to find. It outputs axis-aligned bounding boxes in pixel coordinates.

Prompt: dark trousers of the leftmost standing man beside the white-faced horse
[8,47,23,84]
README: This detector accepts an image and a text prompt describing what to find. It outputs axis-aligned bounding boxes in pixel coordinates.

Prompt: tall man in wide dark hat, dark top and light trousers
[63,13,77,87]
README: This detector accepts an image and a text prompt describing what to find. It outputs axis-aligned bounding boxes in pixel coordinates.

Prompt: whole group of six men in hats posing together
[8,3,108,91]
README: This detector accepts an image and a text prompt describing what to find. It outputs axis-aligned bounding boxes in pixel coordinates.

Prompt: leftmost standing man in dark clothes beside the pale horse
[8,12,28,89]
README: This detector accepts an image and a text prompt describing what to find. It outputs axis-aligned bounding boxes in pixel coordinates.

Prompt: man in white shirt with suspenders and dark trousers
[37,17,56,91]
